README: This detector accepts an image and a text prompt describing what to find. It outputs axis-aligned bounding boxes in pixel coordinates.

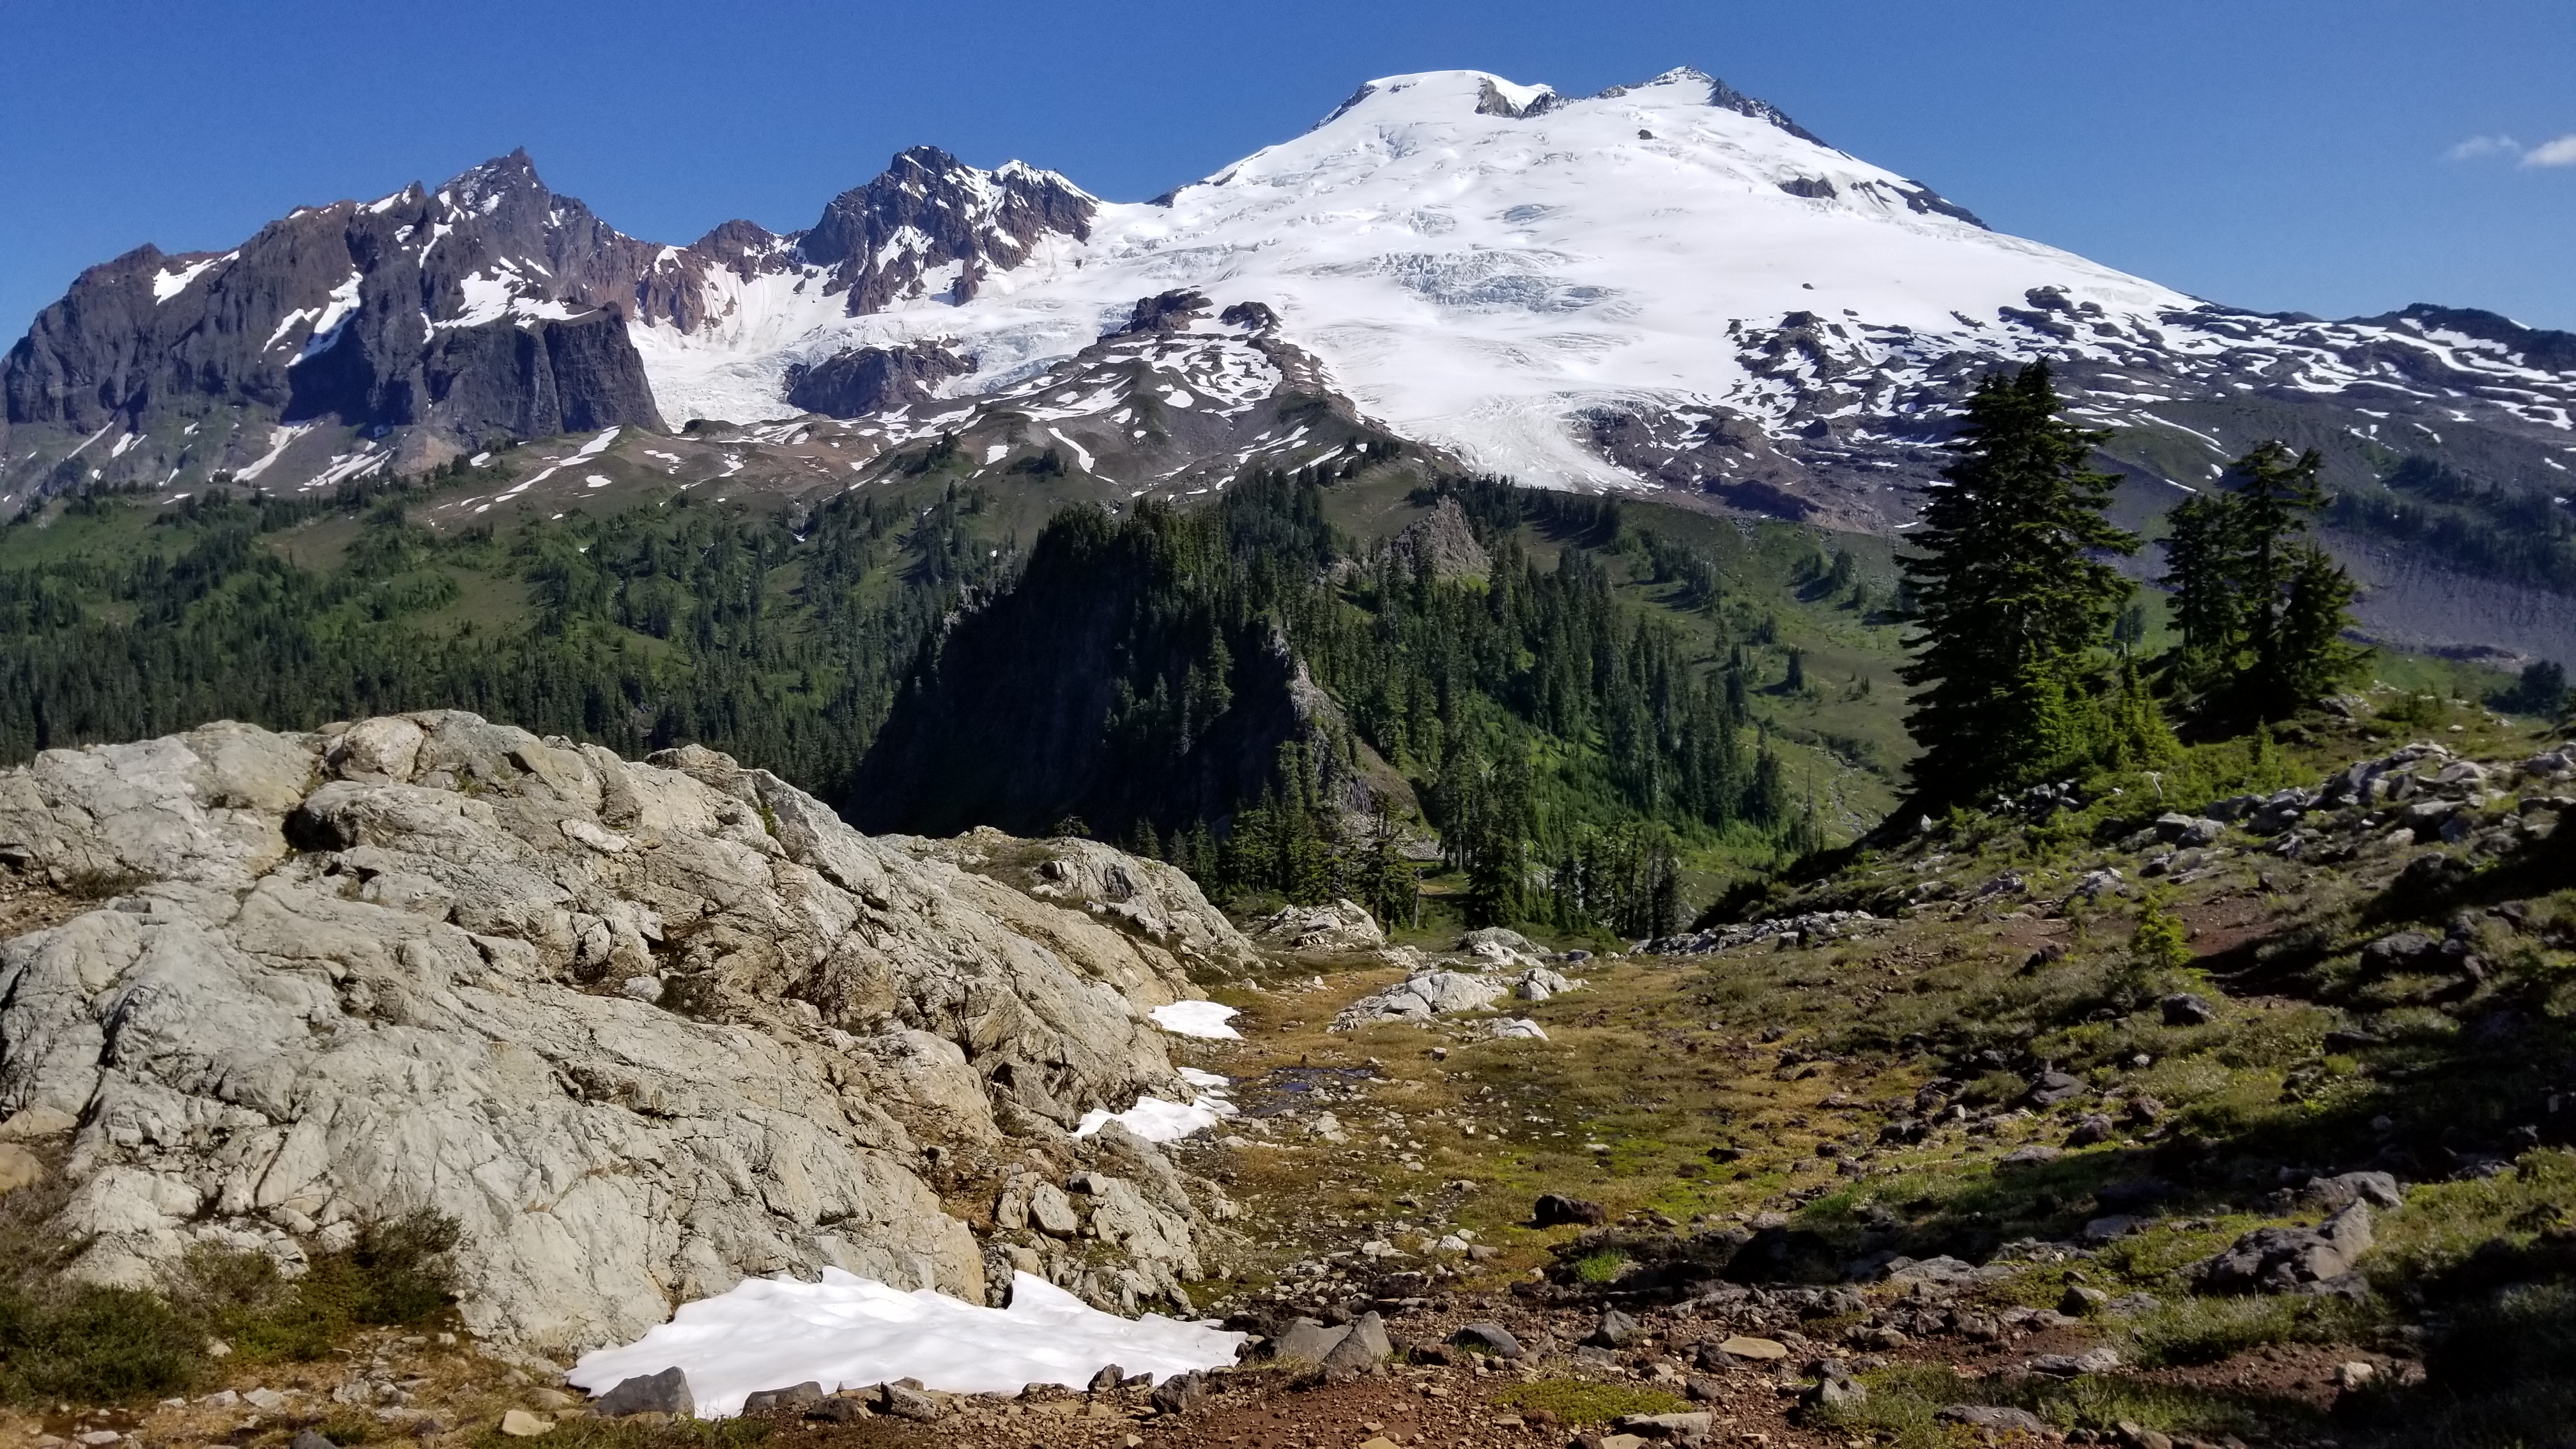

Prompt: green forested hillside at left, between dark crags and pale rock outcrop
[0,479,1008,789]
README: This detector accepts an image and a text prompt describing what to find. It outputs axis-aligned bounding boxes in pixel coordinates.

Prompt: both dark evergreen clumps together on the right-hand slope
[1901,364,2365,807]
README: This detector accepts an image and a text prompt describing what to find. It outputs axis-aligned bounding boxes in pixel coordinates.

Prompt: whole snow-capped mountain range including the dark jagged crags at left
[0,70,2576,562]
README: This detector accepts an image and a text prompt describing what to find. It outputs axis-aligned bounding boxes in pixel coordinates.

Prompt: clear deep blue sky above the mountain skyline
[0,0,2576,338]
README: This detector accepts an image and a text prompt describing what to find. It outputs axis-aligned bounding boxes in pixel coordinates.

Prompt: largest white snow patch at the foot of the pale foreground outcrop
[567,1269,1244,1418]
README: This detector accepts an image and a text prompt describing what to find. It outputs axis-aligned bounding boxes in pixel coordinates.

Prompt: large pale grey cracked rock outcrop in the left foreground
[0,712,1221,1349]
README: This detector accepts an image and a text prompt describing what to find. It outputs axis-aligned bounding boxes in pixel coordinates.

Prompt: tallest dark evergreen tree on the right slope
[1904,364,2138,802]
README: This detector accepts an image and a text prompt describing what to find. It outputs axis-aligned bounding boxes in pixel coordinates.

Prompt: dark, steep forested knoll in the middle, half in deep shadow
[848,475,1808,933]
